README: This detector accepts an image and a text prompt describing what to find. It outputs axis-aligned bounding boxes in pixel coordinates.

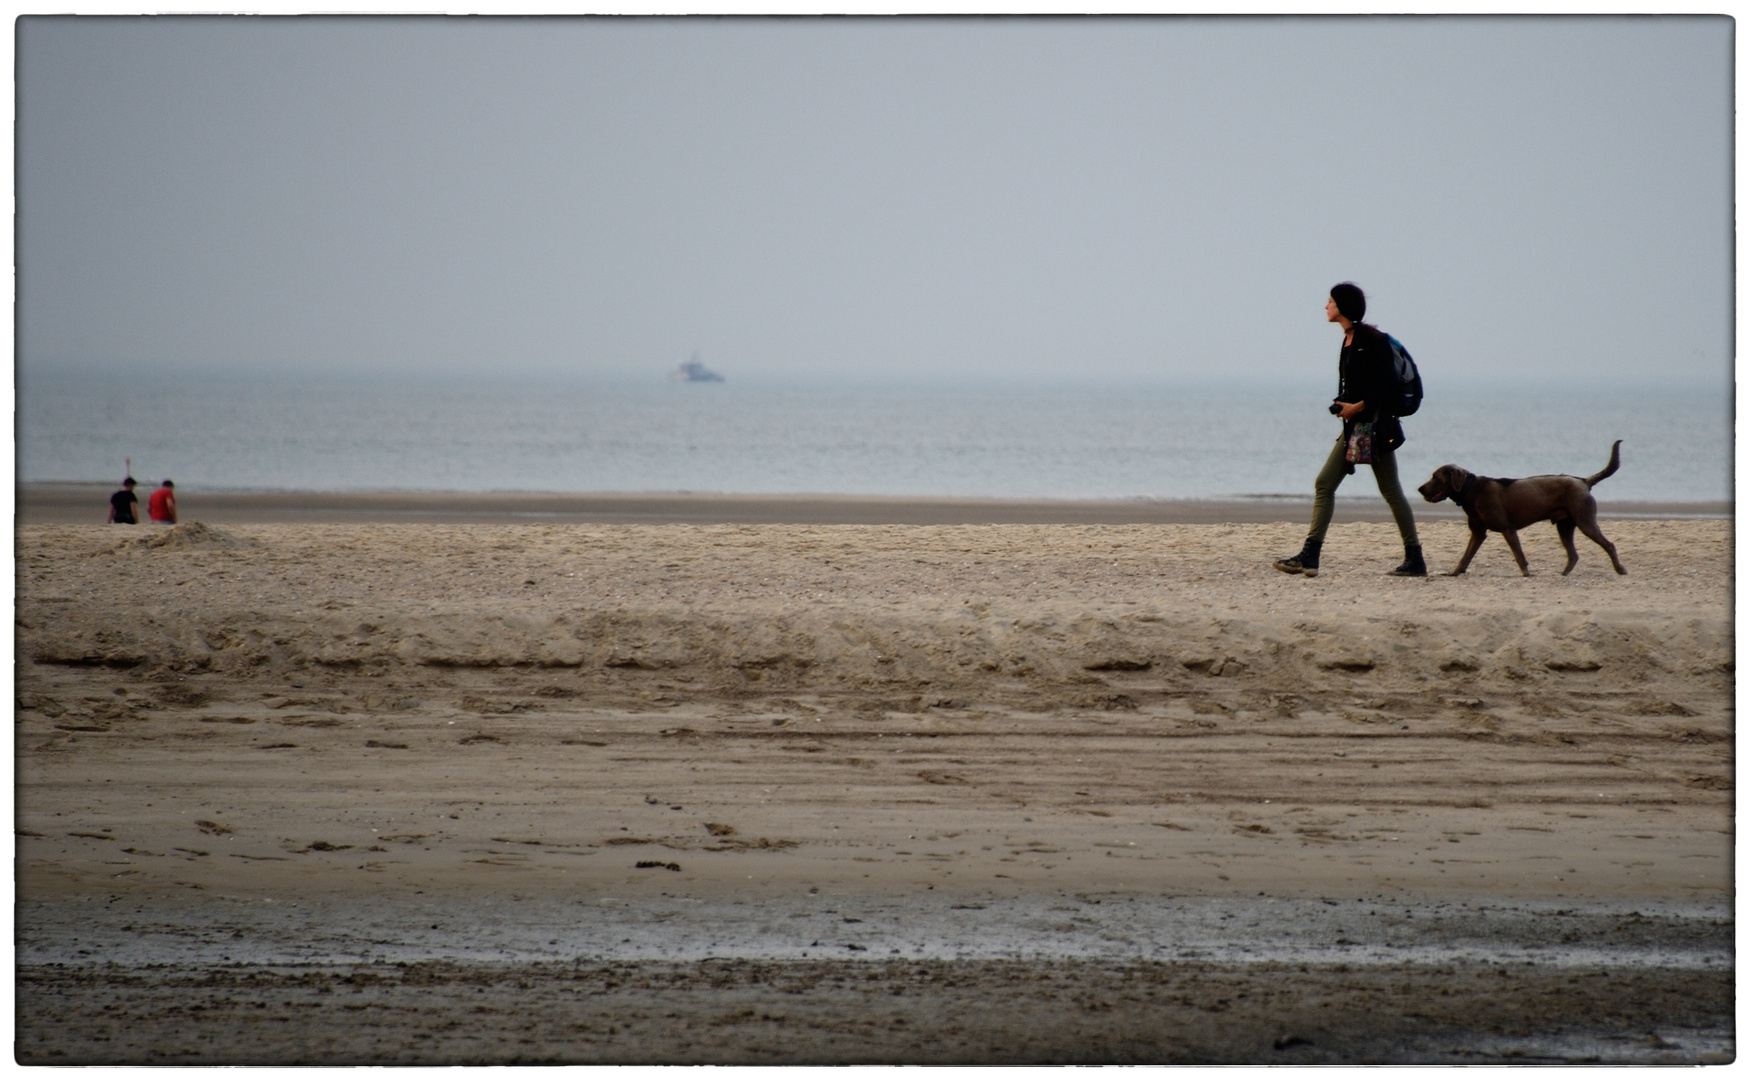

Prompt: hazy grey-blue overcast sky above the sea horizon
[16,18,1733,385]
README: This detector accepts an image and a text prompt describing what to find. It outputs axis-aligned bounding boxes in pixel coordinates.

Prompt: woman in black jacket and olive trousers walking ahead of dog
[1276,282,1428,578]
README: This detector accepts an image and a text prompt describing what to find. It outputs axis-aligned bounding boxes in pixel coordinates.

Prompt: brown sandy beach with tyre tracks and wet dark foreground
[16,511,1736,1062]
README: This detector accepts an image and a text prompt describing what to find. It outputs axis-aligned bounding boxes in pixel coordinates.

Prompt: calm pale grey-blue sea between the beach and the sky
[16,371,1733,502]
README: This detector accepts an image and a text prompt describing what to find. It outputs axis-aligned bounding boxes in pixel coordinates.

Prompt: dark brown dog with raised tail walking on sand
[1416,439,1628,578]
